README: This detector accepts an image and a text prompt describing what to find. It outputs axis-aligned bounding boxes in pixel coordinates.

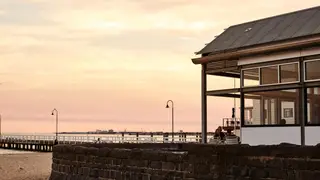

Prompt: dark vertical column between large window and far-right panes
[299,58,308,146]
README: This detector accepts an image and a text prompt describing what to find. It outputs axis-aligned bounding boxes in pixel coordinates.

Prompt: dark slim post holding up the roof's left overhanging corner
[201,64,207,143]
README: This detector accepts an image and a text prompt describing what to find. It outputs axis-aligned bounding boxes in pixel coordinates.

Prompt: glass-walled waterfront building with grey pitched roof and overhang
[192,6,320,145]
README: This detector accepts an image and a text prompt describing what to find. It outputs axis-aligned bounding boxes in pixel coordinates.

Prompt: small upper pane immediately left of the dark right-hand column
[280,63,299,83]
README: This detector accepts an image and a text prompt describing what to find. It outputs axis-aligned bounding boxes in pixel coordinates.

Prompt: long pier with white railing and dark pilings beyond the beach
[0,133,213,152]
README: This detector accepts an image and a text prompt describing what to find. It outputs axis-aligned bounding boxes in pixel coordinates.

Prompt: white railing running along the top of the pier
[0,134,205,144]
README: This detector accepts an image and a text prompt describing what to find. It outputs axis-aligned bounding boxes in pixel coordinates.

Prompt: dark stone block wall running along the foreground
[50,144,320,180]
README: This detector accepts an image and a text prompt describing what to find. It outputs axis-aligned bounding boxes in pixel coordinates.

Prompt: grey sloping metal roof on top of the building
[197,6,320,54]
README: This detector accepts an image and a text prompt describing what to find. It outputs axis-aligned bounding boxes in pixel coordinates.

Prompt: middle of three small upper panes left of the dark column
[260,66,278,84]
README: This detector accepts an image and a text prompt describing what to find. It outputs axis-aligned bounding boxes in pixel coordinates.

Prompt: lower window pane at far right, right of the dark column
[307,87,320,124]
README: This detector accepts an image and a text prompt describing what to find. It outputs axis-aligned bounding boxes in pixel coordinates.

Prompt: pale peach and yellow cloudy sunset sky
[0,0,319,133]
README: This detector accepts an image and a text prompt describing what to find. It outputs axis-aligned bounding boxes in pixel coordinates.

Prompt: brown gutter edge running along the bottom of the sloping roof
[191,36,320,64]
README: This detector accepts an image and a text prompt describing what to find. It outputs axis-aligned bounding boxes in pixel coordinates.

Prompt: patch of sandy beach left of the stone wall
[0,153,52,180]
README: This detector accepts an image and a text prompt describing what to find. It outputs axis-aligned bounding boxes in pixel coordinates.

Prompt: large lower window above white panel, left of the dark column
[244,89,299,125]
